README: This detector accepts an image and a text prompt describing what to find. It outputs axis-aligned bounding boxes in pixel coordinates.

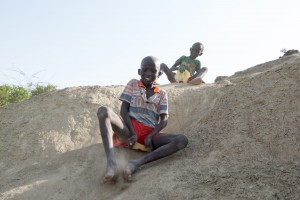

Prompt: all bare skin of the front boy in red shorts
[97,56,188,183]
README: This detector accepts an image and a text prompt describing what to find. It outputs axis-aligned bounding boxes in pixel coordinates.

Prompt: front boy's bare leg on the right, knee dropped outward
[123,133,188,182]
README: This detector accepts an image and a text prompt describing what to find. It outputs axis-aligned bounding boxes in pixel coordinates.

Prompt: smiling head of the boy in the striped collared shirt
[138,56,161,86]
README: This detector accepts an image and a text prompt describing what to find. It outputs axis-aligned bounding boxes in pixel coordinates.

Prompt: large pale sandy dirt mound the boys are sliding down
[0,54,300,200]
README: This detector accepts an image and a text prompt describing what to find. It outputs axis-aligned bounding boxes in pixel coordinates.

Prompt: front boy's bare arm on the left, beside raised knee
[120,101,137,148]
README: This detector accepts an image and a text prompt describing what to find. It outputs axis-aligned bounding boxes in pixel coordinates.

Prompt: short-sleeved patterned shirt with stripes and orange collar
[119,79,168,127]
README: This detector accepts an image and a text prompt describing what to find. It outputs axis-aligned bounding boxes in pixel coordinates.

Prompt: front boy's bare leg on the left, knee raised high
[97,107,129,182]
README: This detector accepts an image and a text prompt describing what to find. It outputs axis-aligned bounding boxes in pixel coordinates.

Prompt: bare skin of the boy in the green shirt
[160,42,203,84]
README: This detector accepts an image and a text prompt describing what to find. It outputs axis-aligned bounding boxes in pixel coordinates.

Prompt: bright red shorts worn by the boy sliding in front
[113,119,159,147]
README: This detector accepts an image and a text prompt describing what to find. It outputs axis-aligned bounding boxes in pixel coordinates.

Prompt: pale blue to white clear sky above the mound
[0,0,300,88]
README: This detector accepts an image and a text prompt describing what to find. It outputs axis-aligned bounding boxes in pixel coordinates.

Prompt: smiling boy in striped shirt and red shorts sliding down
[97,56,188,182]
